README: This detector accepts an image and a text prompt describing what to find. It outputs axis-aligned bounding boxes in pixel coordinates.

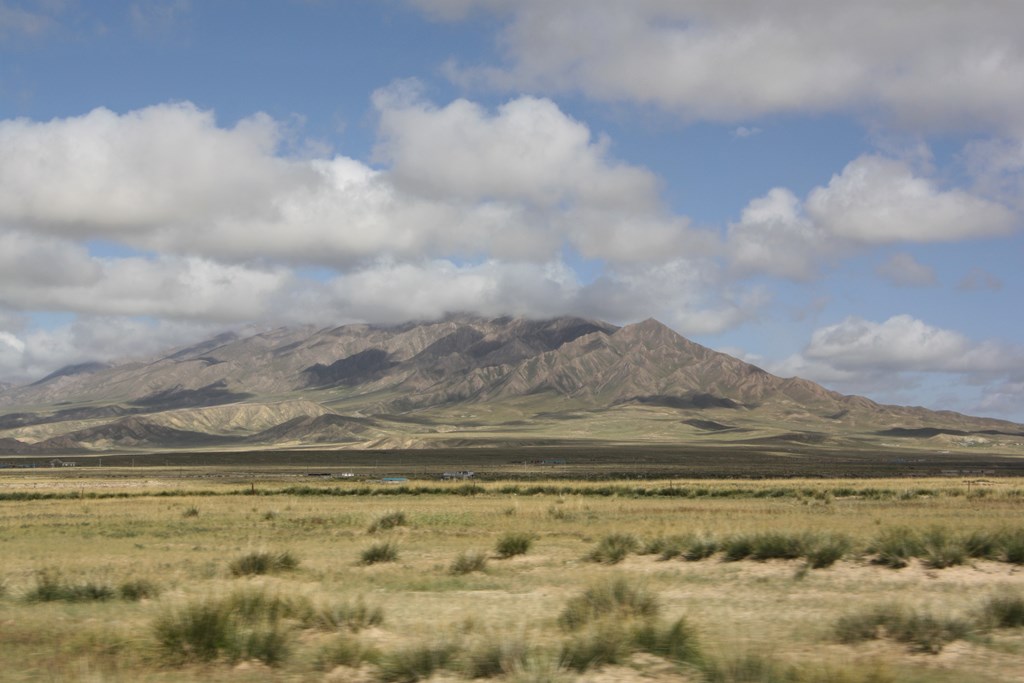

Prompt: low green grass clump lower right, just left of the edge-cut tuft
[834,605,972,654]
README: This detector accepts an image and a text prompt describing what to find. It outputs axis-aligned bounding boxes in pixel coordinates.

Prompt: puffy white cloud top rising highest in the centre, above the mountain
[374,83,657,210]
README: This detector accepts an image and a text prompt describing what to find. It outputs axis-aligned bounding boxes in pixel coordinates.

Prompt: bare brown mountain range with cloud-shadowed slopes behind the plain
[0,316,1024,454]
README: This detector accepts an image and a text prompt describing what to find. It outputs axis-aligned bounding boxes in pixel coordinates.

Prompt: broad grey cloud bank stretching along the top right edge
[411,0,1024,131]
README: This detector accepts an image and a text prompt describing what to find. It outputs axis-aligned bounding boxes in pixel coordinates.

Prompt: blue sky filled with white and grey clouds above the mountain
[0,0,1024,422]
